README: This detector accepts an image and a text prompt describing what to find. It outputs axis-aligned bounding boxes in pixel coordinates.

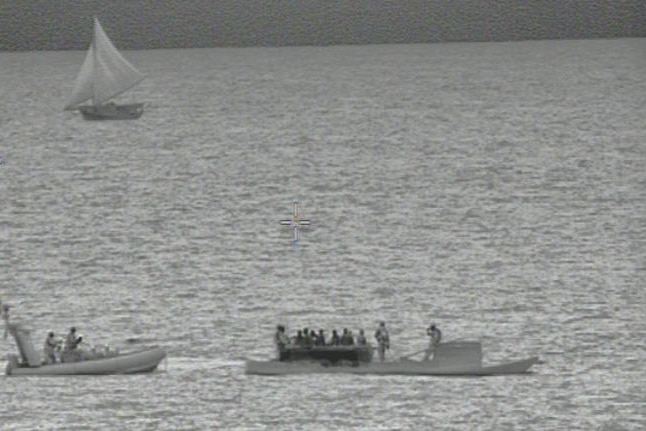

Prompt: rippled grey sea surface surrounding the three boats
[0,39,646,431]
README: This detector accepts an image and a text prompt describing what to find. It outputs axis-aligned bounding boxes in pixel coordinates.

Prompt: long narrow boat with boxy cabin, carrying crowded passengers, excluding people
[245,326,539,376]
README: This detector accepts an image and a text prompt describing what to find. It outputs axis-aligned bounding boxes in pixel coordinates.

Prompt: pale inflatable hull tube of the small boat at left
[6,347,166,376]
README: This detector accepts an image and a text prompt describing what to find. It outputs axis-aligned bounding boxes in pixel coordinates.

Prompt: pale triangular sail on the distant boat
[65,17,146,109]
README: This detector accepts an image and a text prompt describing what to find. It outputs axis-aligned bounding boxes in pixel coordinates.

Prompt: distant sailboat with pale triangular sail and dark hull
[65,17,146,120]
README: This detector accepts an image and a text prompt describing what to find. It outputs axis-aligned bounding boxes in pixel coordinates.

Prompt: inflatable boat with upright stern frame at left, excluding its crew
[6,323,166,376]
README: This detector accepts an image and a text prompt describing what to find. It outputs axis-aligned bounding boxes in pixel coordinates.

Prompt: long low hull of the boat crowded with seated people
[245,357,539,376]
